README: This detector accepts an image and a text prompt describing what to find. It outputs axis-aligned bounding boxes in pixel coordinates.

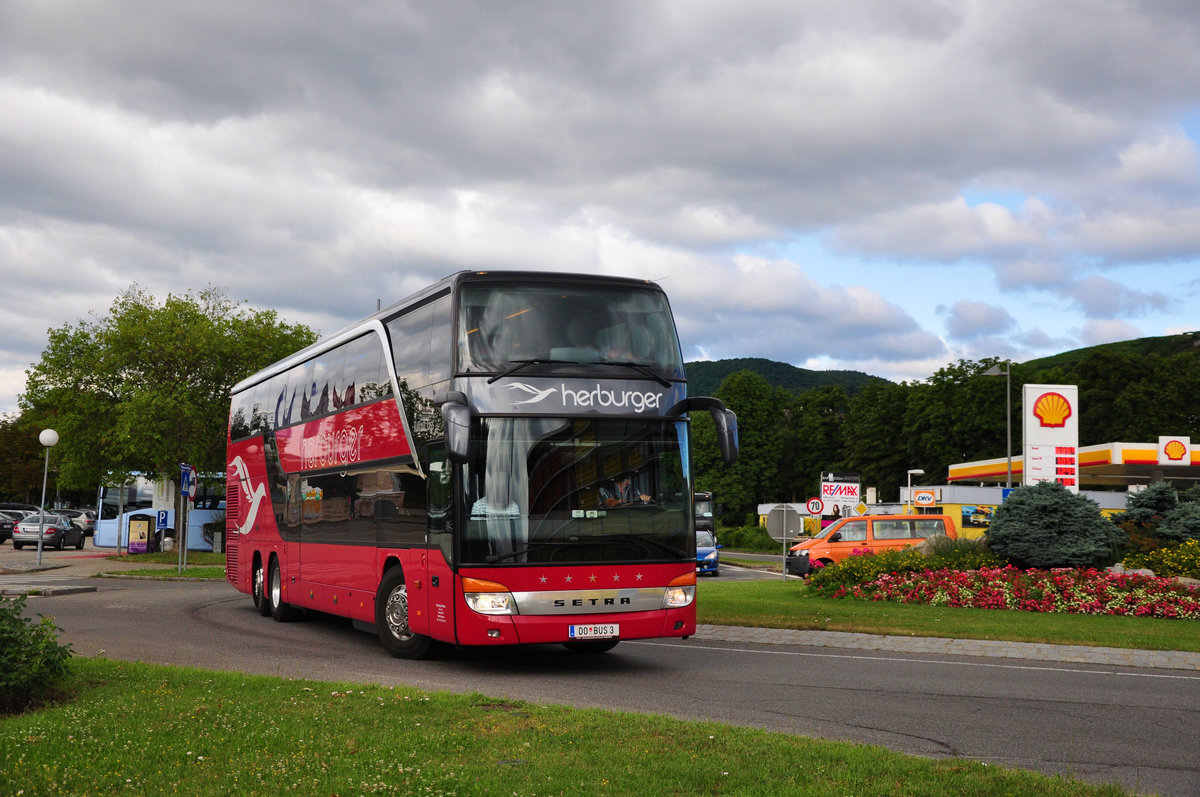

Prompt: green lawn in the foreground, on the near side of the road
[0,659,1126,796]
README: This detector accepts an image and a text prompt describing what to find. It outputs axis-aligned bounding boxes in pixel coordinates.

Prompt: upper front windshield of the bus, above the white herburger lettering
[457,282,683,378]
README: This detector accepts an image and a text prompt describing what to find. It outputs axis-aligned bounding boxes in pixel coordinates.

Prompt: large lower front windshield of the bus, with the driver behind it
[458,418,695,567]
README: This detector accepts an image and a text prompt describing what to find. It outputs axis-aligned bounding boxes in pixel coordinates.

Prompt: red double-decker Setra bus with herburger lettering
[226,271,737,658]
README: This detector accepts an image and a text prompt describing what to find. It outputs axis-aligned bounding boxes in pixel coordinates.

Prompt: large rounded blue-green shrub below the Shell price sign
[988,481,1123,568]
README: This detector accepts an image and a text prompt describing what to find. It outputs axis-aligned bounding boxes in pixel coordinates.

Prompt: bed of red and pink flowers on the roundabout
[830,565,1200,619]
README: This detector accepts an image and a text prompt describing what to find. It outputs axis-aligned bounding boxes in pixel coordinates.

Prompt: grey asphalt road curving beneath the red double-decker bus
[0,547,1200,797]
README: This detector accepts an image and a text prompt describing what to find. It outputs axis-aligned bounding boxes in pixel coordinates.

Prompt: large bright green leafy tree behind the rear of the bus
[20,284,317,487]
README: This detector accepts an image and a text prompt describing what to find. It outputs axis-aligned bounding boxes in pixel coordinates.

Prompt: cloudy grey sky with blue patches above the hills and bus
[0,0,1200,412]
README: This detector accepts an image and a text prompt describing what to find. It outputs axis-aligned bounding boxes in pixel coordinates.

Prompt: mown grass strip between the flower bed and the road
[696,579,1200,652]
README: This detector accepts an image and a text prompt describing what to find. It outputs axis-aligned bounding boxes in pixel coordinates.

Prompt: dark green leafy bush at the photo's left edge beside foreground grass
[0,595,71,714]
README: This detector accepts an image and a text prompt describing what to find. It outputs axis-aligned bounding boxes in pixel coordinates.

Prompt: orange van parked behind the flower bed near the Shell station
[787,515,959,576]
